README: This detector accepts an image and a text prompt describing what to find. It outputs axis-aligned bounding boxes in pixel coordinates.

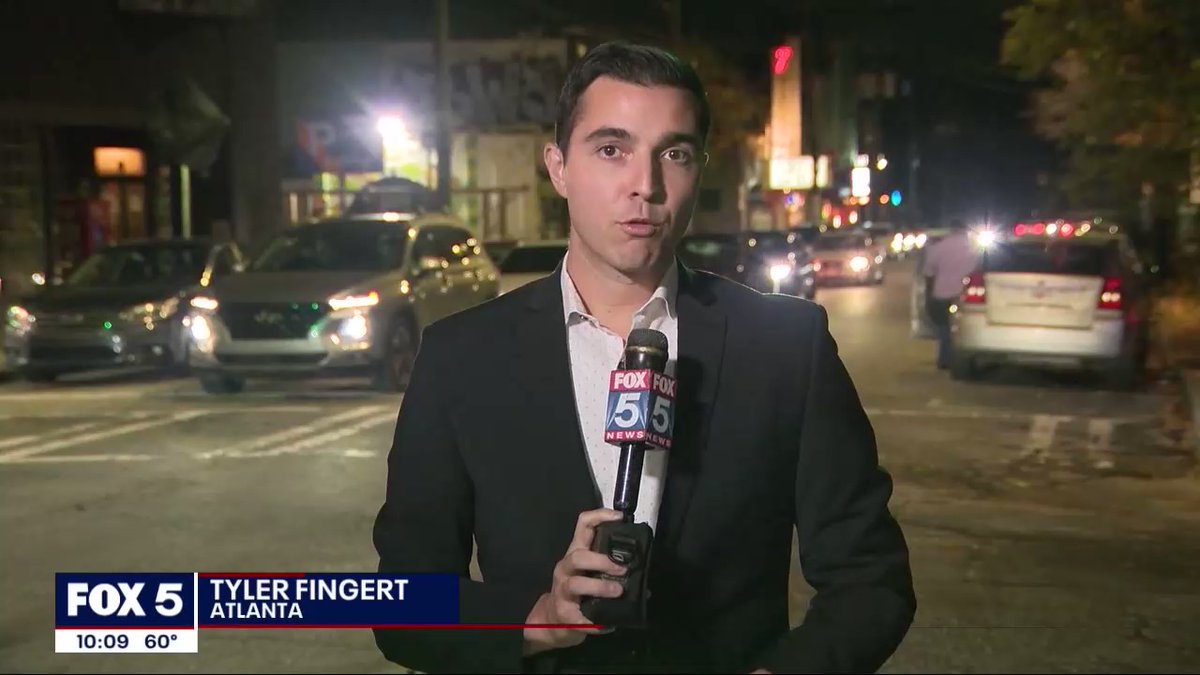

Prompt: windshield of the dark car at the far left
[66,244,209,286]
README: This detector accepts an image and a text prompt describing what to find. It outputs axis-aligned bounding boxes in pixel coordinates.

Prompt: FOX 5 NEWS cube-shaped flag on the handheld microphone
[604,370,677,450]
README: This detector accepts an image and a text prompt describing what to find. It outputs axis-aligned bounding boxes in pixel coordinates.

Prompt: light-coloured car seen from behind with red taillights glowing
[950,223,1150,389]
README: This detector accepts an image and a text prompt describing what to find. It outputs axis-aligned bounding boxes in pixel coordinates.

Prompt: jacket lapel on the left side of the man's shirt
[512,264,604,514]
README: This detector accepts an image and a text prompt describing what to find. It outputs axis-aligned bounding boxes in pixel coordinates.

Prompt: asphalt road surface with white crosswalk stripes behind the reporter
[0,255,1200,673]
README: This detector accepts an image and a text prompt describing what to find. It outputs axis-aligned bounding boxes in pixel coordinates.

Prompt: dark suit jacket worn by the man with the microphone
[374,265,916,673]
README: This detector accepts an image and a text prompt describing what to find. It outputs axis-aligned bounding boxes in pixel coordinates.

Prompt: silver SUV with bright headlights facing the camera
[186,213,499,394]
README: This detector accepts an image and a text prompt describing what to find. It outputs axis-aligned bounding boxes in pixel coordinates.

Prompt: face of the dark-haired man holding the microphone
[545,77,706,279]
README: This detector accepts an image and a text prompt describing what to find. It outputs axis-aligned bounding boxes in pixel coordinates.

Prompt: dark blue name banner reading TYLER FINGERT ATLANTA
[198,573,458,628]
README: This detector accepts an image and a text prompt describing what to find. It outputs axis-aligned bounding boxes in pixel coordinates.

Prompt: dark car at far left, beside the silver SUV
[5,239,244,382]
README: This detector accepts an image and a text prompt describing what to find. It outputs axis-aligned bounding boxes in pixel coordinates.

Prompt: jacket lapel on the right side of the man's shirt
[654,264,726,559]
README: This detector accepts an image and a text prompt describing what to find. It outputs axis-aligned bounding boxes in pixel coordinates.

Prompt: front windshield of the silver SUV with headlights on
[251,221,408,271]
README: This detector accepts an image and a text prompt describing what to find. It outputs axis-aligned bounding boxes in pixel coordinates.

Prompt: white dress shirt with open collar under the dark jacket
[562,253,679,528]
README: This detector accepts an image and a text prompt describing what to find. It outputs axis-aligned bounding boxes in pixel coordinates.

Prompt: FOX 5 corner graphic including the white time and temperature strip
[54,573,199,653]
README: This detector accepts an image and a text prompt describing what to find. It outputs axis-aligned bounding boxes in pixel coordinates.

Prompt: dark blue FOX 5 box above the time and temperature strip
[54,572,196,628]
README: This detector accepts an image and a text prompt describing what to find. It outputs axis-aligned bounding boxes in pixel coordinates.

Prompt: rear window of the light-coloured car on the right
[983,240,1120,276]
